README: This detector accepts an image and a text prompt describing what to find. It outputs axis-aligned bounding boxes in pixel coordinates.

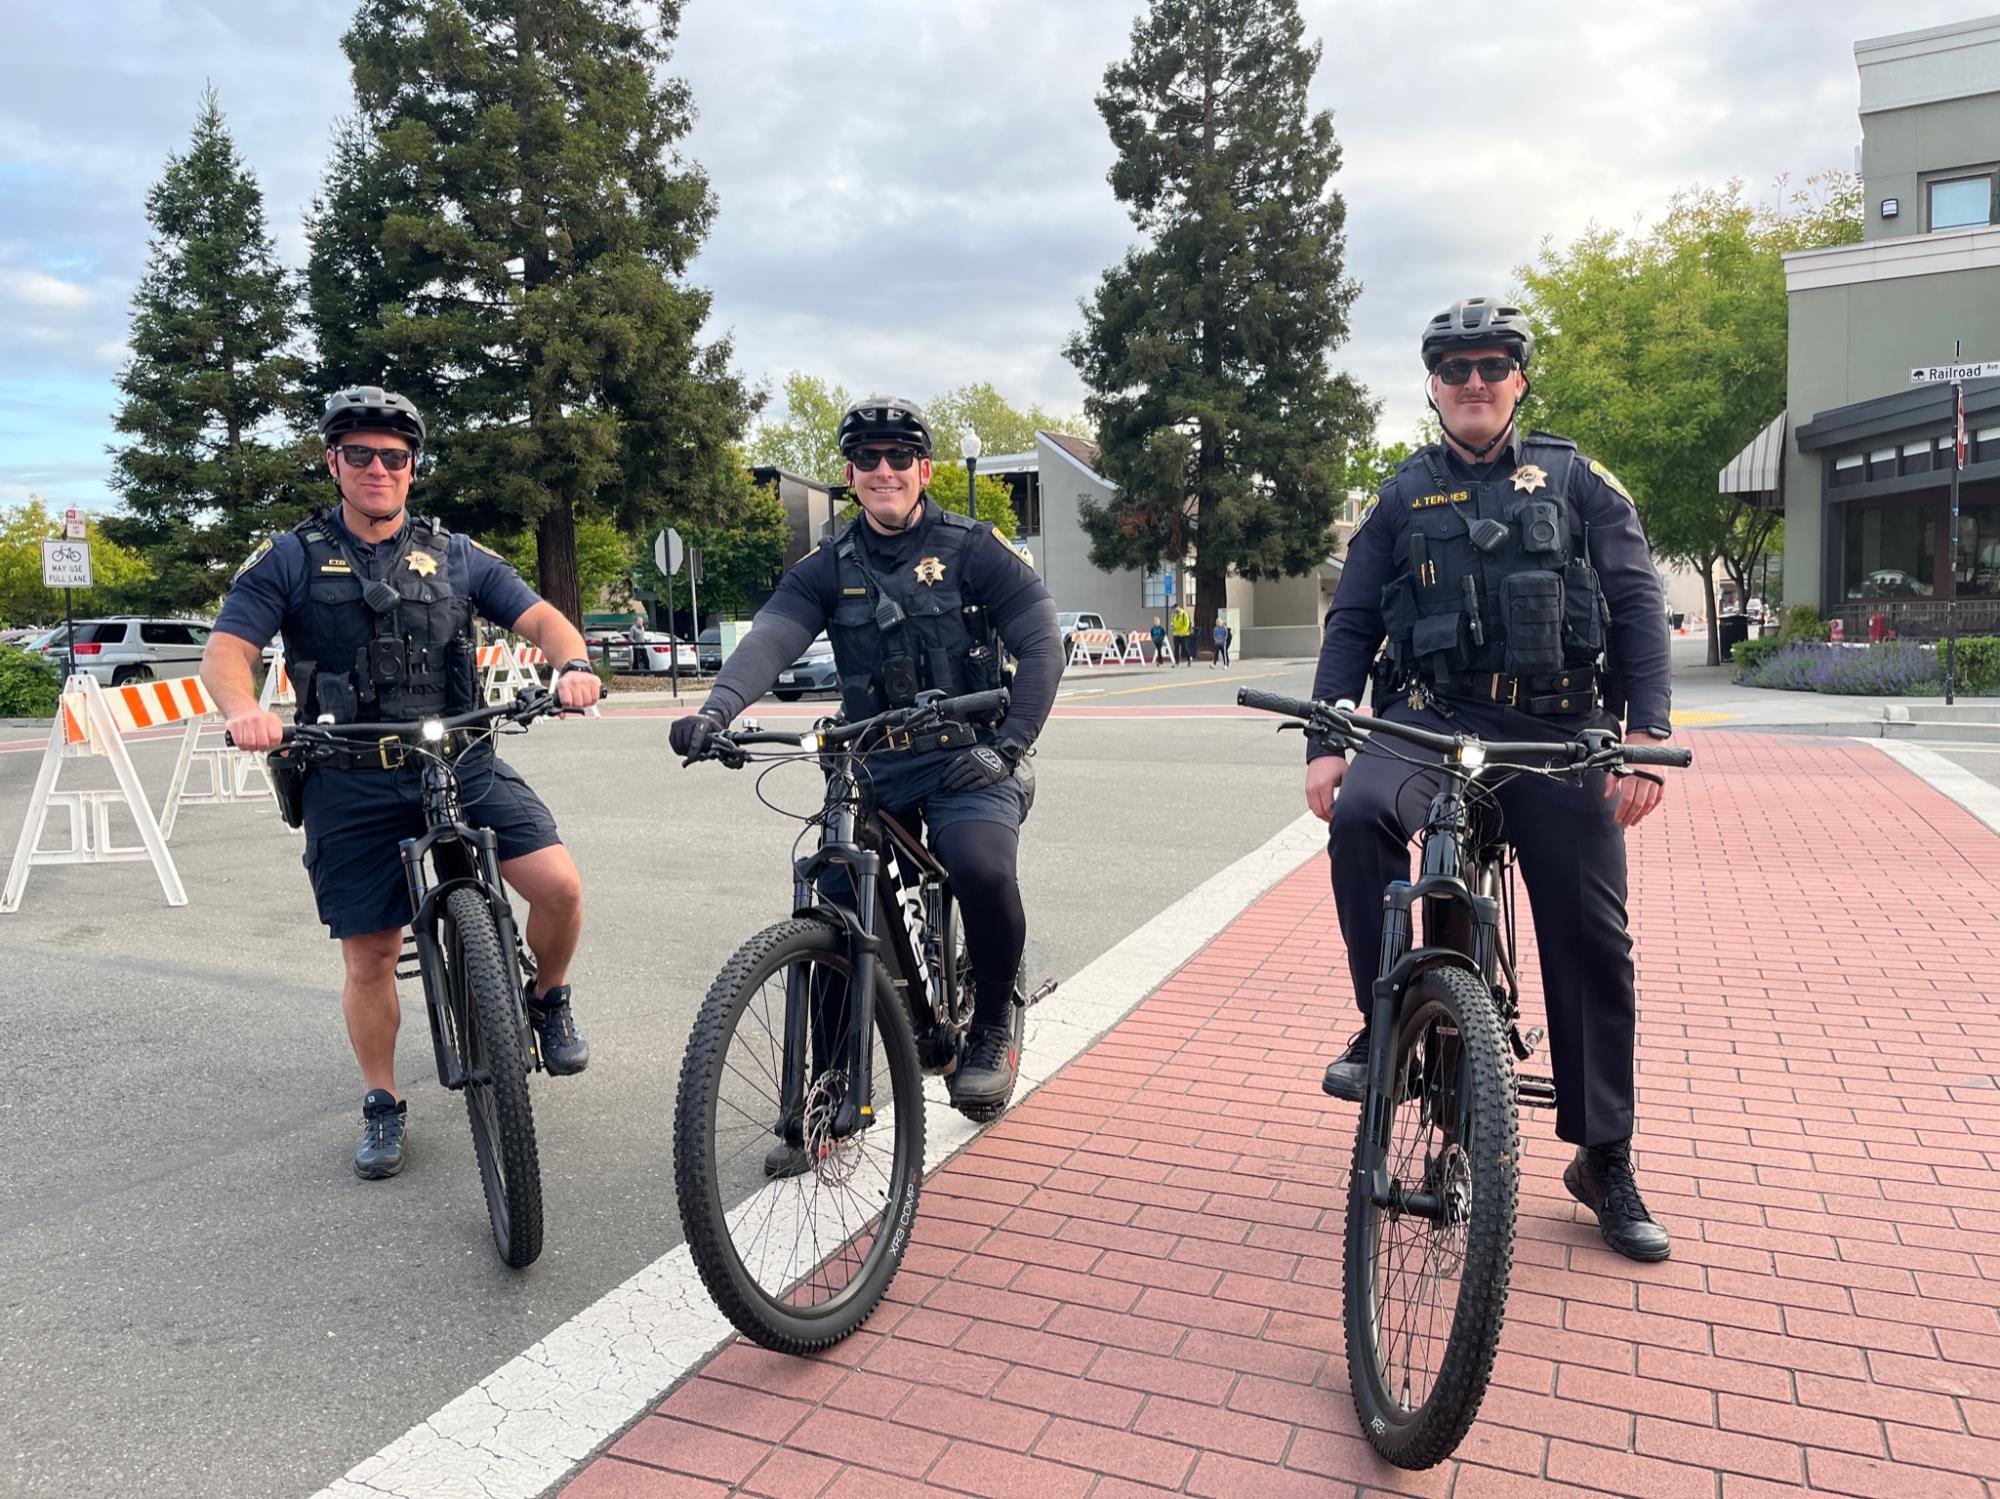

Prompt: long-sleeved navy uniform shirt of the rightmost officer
[1308,432,1672,759]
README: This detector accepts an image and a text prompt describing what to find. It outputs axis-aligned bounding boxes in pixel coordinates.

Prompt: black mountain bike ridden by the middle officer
[674,688,1056,1353]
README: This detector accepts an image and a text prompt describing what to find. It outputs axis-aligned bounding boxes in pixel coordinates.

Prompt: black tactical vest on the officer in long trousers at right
[1382,432,1610,696]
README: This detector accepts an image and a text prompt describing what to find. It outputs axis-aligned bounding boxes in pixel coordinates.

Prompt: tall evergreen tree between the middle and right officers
[1066,0,1376,640]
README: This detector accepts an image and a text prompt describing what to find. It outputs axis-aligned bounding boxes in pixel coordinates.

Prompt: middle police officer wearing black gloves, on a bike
[670,396,1062,1135]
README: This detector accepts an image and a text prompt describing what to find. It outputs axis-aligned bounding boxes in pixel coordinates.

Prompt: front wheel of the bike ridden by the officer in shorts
[444,885,542,1269]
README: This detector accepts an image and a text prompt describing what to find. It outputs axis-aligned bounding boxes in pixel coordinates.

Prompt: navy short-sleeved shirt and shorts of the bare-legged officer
[216,510,562,937]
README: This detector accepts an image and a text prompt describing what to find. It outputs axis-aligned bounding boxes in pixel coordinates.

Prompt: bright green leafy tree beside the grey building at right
[1516,172,1862,664]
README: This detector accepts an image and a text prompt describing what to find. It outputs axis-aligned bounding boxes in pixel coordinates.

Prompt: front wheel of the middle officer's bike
[674,919,924,1353]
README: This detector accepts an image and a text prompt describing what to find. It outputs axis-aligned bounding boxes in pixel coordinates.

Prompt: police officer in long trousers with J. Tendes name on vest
[1306,296,1670,1259]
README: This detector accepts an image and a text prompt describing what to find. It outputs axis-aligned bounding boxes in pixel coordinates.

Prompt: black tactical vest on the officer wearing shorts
[284,512,480,724]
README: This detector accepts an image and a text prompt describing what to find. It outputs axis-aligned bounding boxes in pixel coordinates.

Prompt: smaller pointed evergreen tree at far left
[104,88,312,610]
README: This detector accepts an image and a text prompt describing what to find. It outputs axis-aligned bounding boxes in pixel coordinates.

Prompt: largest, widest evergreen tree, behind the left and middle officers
[308,0,752,620]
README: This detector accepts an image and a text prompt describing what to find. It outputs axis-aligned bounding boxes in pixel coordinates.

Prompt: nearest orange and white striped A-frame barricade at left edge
[0,674,191,911]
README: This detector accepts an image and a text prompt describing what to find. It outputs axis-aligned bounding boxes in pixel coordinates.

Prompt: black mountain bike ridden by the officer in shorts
[250,688,562,1269]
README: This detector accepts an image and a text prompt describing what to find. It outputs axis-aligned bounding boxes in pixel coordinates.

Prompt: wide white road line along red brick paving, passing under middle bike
[314,815,1326,1499]
